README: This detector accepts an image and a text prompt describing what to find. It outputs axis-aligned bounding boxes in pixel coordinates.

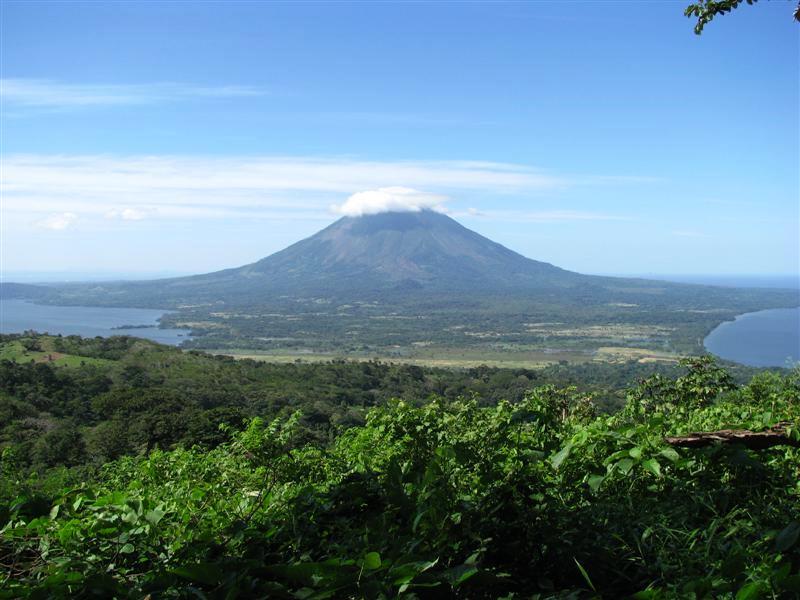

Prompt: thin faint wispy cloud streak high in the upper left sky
[0,79,265,108]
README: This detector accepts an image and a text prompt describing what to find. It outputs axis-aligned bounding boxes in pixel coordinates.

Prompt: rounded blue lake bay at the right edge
[704,308,800,367]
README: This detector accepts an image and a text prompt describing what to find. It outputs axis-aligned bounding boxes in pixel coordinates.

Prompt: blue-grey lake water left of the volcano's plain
[0,300,191,346]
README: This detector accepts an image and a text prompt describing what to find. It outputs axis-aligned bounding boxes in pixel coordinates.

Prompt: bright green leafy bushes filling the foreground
[0,338,800,599]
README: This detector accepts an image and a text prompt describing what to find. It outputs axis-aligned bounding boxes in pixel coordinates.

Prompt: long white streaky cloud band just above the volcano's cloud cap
[3,155,569,197]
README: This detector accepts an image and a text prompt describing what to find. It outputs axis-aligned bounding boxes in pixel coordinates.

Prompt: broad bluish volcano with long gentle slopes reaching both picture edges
[0,210,796,336]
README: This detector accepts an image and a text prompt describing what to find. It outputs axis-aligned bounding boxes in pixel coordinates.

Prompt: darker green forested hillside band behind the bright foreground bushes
[0,335,728,471]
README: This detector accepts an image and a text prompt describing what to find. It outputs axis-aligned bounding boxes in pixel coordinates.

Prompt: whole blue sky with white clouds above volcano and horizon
[0,0,800,277]
